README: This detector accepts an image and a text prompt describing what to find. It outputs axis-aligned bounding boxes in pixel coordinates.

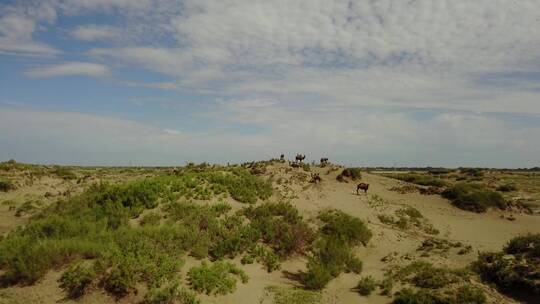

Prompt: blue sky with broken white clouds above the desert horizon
[0,0,540,167]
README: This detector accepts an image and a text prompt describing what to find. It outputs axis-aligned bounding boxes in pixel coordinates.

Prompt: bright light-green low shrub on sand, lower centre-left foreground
[188,261,249,295]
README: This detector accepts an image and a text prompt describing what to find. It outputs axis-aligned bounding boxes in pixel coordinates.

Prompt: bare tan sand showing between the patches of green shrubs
[0,164,540,304]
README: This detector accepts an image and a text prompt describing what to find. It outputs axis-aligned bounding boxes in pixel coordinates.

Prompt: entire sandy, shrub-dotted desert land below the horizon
[0,158,540,304]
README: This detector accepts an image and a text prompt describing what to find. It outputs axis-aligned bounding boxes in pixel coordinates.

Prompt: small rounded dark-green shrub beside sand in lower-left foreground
[58,263,96,298]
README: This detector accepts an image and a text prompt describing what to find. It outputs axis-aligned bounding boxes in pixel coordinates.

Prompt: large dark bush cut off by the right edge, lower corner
[473,234,540,295]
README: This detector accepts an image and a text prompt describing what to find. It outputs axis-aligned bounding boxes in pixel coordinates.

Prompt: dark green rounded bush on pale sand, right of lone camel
[442,183,507,212]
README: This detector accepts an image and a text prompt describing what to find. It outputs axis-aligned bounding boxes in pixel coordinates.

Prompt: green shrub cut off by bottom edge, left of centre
[144,282,200,304]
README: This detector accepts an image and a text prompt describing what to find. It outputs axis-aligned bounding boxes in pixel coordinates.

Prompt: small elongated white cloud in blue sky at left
[25,62,110,78]
